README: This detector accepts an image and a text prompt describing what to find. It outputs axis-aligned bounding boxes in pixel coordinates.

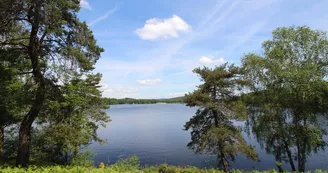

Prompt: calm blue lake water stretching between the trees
[91,104,328,170]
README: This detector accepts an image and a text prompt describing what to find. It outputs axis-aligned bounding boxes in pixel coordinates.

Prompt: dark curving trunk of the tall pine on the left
[16,1,45,167]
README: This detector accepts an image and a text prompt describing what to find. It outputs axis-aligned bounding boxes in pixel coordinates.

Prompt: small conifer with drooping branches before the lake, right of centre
[185,64,257,172]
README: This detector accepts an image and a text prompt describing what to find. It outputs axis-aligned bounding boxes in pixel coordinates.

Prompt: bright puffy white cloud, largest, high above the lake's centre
[135,15,191,40]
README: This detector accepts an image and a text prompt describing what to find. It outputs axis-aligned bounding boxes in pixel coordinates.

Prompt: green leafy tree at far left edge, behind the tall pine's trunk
[0,26,29,159]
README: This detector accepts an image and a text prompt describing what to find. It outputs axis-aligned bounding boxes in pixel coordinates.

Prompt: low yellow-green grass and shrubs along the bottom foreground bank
[0,156,328,173]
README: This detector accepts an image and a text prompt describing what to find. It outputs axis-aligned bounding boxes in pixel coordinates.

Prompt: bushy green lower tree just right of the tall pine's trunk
[34,74,110,164]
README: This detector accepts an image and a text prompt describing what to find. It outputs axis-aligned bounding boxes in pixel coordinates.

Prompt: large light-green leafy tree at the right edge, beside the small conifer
[242,26,328,172]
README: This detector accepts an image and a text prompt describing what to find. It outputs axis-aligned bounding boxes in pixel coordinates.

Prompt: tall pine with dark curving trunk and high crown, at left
[0,0,103,166]
